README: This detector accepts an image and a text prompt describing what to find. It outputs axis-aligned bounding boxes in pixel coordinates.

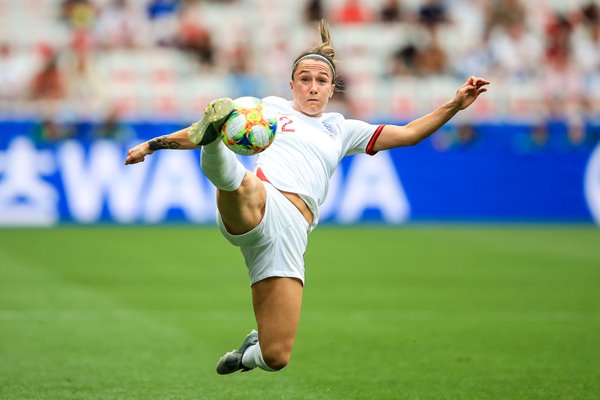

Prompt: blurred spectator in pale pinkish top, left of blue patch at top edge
[96,0,148,49]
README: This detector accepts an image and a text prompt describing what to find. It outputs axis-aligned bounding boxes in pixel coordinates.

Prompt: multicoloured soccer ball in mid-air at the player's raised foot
[221,97,277,156]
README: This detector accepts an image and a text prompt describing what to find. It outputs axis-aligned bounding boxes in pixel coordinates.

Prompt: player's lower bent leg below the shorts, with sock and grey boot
[217,277,303,375]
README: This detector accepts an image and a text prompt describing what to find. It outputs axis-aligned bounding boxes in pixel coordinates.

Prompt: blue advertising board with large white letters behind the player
[0,121,600,226]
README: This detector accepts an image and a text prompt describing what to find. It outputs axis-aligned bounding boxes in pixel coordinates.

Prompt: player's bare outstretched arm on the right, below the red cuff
[373,76,490,151]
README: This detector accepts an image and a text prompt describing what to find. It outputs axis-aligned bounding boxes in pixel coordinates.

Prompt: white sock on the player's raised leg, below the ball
[200,139,247,192]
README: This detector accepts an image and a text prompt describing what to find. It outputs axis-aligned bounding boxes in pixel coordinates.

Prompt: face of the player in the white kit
[290,59,335,117]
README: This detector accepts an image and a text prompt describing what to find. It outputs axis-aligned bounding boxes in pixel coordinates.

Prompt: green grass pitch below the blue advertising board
[0,226,600,400]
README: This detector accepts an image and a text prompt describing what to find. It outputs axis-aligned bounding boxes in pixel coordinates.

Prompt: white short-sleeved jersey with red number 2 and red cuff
[256,96,383,228]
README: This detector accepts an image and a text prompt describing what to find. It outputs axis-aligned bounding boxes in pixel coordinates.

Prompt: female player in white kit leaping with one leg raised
[125,21,489,374]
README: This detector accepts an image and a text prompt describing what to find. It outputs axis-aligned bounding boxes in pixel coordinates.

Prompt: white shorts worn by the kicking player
[217,182,310,285]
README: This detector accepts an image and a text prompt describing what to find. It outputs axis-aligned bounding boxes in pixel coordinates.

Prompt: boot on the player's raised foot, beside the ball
[188,98,233,146]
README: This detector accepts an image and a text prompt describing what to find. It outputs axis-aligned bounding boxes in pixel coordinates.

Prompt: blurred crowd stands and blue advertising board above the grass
[0,0,600,225]
